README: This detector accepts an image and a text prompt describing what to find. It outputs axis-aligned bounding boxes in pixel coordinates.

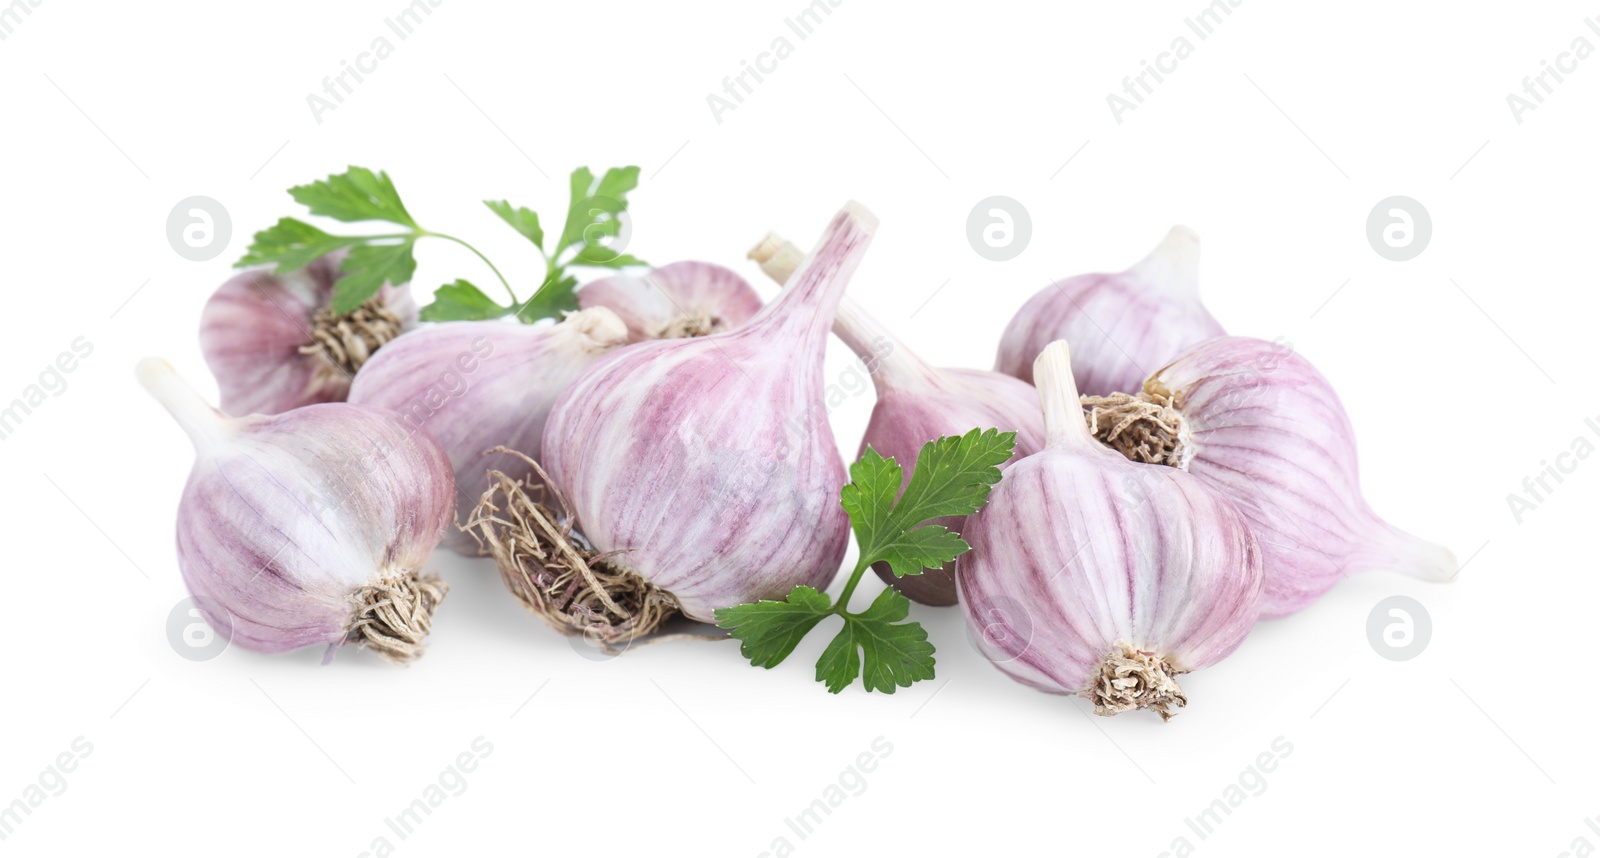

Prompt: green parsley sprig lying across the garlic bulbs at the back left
[235,166,645,322]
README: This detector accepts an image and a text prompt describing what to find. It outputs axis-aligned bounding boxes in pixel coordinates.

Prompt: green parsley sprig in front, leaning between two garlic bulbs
[717,429,1016,695]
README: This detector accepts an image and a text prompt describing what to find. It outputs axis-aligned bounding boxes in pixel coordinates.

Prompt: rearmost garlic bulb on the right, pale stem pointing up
[995,226,1224,395]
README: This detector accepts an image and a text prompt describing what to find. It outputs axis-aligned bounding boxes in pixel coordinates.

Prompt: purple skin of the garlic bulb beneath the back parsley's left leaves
[200,251,418,415]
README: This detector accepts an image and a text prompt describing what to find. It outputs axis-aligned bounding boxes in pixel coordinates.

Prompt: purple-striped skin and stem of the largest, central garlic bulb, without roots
[542,203,877,623]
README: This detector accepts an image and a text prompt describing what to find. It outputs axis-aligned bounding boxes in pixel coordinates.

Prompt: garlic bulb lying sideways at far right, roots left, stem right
[1083,336,1458,618]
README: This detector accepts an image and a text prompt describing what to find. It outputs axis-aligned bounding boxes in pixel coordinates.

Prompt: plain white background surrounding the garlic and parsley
[0,0,1600,855]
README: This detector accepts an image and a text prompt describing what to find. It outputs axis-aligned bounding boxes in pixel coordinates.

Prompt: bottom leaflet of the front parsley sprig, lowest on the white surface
[819,587,934,695]
